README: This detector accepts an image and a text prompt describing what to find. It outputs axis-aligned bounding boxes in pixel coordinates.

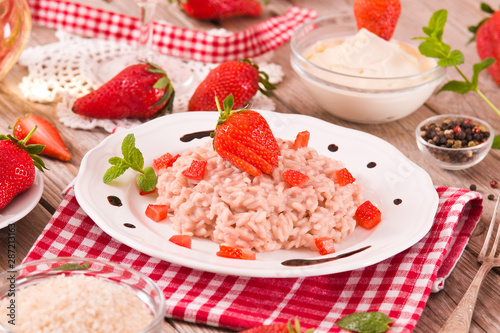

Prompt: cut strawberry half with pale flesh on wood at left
[14,114,71,161]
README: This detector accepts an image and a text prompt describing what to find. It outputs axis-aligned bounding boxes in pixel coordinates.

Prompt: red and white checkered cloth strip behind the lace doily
[28,0,317,63]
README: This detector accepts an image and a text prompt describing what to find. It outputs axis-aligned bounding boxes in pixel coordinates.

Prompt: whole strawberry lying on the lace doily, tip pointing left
[73,63,174,119]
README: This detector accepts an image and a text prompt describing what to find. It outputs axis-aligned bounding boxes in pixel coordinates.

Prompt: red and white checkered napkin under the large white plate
[25,187,483,332]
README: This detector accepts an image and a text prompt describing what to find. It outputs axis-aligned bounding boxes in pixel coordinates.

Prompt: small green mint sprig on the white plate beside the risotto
[102,134,156,192]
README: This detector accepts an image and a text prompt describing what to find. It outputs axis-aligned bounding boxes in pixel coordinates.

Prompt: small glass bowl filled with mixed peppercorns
[415,114,495,170]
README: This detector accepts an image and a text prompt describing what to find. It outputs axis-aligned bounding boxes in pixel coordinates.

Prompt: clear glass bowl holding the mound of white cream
[290,15,446,123]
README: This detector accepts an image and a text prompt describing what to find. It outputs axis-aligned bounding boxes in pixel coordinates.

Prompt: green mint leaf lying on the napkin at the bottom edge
[337,312,393,333]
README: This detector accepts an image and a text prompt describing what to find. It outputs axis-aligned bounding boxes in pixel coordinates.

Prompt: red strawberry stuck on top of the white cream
[353,0,401,40]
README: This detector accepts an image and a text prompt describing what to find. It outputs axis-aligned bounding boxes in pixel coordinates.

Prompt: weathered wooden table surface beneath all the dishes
[0,0,500,333]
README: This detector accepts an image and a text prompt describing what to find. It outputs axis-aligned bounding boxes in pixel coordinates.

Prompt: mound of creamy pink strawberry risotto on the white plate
[156,138,363,252]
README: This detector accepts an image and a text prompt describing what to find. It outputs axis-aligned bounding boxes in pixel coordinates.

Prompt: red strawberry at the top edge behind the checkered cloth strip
[169,0,262,20]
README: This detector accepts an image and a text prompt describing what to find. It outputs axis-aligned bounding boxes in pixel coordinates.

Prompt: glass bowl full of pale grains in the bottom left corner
[0,257,165,333]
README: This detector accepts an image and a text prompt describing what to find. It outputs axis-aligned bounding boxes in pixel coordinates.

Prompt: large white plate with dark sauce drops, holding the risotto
[75,111,438,277]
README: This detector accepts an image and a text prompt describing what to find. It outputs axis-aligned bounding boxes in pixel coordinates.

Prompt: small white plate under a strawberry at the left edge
[0,169,43,229]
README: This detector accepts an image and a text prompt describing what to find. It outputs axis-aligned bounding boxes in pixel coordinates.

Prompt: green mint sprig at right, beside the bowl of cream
[414,9,500,116]
